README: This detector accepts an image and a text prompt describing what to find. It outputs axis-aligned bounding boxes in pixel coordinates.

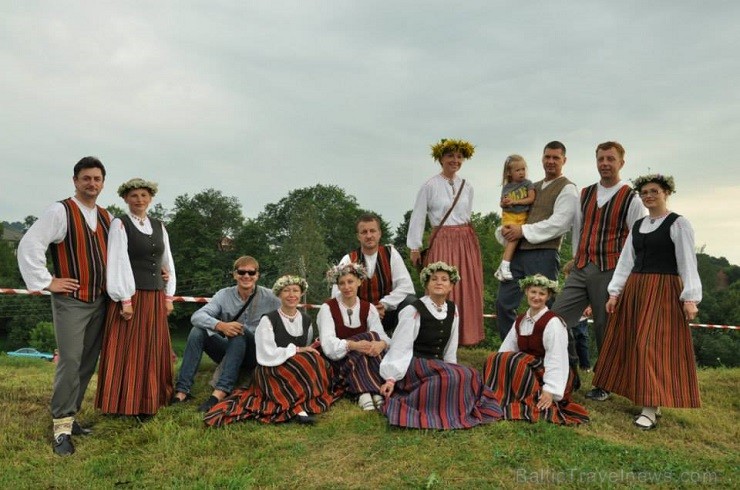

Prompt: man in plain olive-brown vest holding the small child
[496,141,578,339]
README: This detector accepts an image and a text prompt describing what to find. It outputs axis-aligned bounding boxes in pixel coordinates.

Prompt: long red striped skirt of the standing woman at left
[95,290,174,415]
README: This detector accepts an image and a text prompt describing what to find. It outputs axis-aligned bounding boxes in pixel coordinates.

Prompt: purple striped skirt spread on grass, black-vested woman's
[381,357,501,429]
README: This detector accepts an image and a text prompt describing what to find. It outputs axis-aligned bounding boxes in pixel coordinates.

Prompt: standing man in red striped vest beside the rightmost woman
[552,141,647,401]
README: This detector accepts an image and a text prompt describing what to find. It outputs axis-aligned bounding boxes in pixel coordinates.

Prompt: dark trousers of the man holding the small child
[496,249,556,340]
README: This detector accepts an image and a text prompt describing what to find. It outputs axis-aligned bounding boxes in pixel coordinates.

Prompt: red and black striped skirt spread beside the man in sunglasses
[204,352,340,427]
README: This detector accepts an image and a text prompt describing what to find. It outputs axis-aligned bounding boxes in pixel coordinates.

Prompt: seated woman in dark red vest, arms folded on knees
[316,262,391,410]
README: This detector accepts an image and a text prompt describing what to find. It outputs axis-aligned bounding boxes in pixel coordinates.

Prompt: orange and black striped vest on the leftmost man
[50,198,110,303]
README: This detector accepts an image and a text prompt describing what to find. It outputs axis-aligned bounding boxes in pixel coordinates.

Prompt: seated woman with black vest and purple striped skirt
[380,262,501,429]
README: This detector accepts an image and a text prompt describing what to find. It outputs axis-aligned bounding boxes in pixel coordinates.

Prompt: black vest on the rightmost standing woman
[632,213,679,275]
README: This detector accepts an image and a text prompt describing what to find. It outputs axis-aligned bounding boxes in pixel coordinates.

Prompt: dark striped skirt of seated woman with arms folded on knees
[329,332,384,395]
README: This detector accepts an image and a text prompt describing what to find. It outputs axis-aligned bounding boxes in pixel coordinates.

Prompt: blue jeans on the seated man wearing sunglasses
[175,327,257,393]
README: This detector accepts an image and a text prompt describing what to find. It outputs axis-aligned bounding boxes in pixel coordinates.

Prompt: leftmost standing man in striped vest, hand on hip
[18,157,111,456]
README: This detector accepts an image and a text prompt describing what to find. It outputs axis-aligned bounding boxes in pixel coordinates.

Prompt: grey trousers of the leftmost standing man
[51,294,108,419]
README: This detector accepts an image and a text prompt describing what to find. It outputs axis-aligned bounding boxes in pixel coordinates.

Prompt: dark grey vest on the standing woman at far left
[121,215,164,291]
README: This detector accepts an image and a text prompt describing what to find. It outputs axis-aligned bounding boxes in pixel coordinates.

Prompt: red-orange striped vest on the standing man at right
[575,184,635,271]
